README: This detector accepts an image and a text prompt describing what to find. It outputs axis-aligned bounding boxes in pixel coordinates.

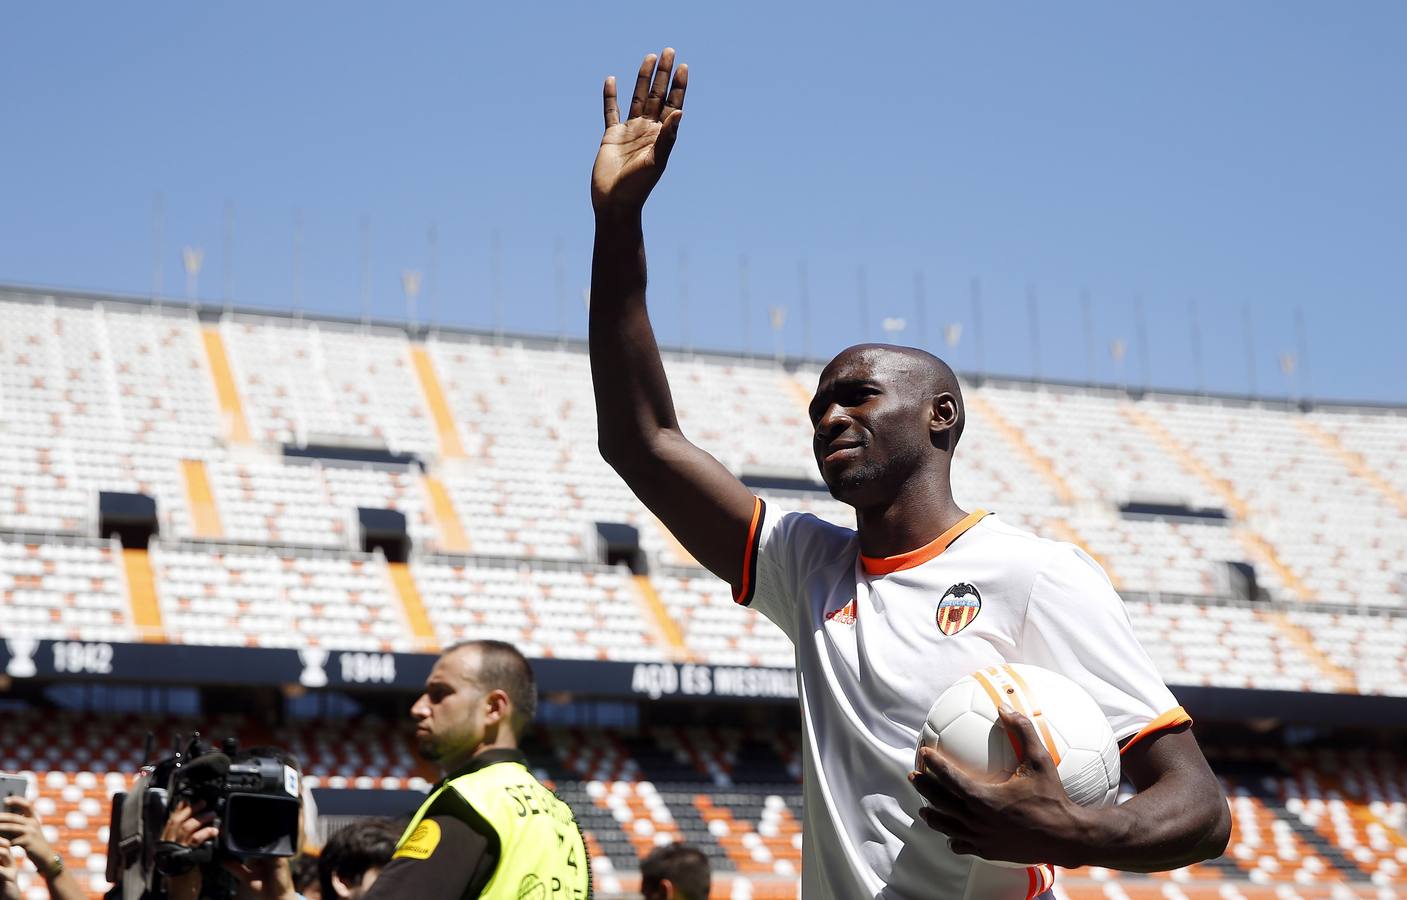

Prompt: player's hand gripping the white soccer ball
[909,709,1090,865]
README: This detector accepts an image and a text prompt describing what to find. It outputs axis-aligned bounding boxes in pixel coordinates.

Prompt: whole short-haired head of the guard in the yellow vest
[411,641,537,772]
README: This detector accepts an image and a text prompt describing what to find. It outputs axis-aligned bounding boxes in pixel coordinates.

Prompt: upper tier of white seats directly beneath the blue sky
[0,293,1407,605]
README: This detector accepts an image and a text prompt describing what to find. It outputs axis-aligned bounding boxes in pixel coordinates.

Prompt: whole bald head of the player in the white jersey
[809,343,967,508]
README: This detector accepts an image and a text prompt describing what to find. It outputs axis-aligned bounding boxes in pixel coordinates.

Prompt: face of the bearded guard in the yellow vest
[411,650,485,769]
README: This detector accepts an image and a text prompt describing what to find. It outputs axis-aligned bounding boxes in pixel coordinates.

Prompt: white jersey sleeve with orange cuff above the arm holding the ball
[1020,544,1192,747]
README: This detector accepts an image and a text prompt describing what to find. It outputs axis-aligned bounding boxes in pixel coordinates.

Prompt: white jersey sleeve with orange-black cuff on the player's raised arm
[733,498,834,644]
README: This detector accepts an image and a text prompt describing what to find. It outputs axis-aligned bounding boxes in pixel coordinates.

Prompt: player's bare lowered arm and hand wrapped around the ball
[909,712,1231,872]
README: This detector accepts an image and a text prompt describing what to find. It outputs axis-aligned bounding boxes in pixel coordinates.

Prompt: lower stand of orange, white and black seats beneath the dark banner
[0,713,1407,899]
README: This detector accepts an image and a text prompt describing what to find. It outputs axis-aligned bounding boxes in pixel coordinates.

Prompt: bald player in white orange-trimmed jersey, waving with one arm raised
[590,49,1231,900]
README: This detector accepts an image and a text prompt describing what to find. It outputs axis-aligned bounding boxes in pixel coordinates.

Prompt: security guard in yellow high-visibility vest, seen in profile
[366,641,591,900]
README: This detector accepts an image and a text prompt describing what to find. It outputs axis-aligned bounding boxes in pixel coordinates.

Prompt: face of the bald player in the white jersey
[809,349,930,506]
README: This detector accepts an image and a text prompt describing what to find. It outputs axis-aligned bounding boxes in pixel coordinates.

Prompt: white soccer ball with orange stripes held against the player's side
[915,662,1119,865]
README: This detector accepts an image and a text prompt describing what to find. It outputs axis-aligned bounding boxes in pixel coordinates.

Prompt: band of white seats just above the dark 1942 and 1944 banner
[0,534,1407,696]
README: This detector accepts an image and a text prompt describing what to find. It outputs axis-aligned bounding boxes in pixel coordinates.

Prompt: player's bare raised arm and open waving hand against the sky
[590,49,756,586]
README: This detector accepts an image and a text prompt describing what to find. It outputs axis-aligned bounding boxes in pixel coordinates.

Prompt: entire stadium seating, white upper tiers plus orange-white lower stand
[0,291,1407,900]
